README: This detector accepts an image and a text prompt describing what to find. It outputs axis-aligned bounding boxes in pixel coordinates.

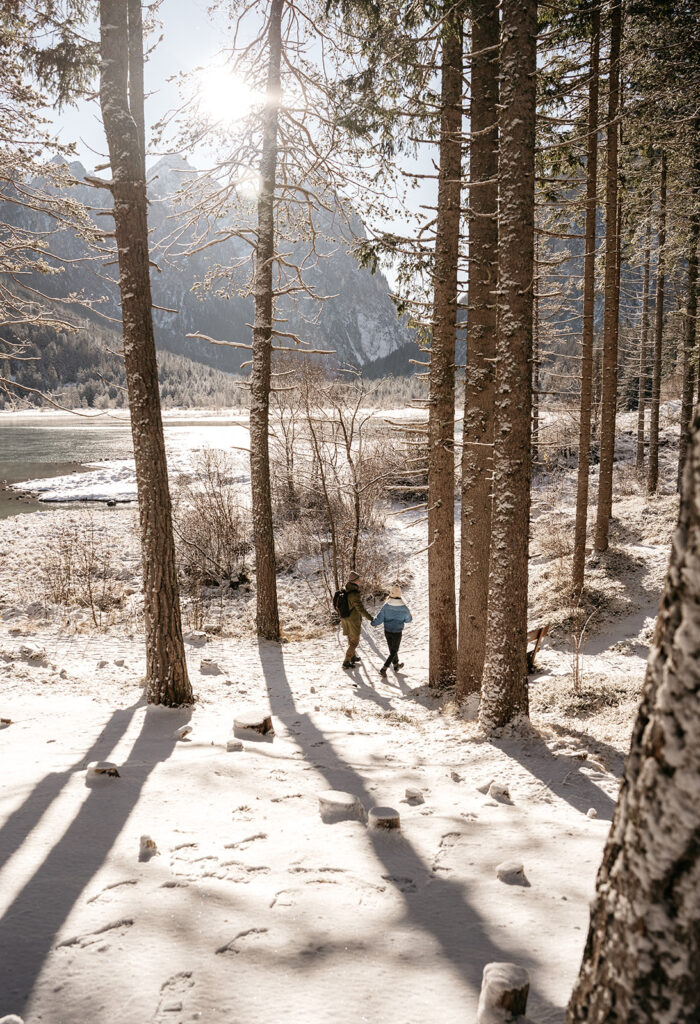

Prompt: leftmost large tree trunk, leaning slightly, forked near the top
[99,0,192,707]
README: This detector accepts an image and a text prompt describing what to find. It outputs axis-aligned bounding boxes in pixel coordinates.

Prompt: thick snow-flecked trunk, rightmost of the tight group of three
[479,0,537,731]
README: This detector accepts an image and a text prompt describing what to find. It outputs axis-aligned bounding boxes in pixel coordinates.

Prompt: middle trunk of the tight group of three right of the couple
[456,0,498,700]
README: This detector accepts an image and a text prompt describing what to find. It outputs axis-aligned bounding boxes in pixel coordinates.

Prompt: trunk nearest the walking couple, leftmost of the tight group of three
[428,3,464,686]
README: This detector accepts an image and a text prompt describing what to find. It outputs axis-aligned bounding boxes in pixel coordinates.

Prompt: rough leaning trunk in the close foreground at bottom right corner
[567,411,700,1024]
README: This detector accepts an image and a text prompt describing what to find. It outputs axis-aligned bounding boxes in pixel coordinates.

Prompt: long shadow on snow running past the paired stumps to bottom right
[258,640,564,1021]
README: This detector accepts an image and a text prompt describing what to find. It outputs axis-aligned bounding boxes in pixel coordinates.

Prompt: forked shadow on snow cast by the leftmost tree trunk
[0,699,191,1016]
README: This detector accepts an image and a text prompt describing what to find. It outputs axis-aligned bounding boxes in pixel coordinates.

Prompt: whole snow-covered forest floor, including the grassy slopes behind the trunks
[0,403,674,1024]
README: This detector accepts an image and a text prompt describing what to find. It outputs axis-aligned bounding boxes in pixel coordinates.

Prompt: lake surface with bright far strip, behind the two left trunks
[0,416,249,518]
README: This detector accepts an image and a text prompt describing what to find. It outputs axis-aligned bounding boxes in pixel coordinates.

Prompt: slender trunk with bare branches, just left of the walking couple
[250,0,285,640]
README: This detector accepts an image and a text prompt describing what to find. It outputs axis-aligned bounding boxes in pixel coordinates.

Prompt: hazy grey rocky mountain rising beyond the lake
[2,157,412,380]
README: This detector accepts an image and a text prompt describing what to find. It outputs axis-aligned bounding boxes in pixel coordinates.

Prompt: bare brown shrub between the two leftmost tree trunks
[173,449,251,588]
